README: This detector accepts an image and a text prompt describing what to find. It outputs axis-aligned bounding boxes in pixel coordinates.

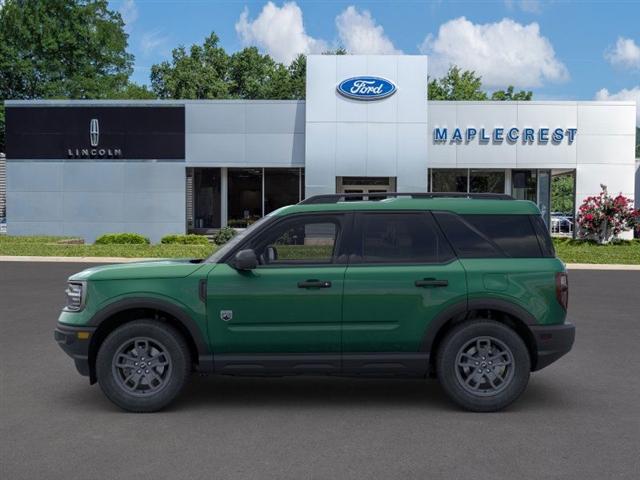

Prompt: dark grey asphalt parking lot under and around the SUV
[0,262,640,480]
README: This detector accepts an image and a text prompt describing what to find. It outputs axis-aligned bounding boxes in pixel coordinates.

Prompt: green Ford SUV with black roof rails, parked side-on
[55,194,575,412]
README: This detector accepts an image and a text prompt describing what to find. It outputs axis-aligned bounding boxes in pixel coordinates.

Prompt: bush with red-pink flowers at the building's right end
[578,185,640,243]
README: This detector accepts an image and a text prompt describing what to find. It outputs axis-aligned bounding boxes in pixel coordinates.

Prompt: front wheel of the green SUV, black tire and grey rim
[96,320,191,413]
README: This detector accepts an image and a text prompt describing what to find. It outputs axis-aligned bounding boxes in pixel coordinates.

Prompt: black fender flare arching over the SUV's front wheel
[87,297,213,371]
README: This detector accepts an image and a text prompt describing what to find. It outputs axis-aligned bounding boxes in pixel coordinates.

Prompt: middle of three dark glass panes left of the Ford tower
[227,168,262,228]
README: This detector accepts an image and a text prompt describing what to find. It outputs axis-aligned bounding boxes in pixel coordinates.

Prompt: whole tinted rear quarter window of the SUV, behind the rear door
[436,213,547,258]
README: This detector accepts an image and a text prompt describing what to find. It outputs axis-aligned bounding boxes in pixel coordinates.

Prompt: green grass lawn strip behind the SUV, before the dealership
[0,235,640,265]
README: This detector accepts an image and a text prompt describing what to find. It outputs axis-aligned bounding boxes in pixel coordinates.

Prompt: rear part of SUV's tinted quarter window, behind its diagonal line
[464,215,542,258]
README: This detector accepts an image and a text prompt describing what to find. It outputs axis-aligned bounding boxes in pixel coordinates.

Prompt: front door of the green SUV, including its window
[207,214,350,371]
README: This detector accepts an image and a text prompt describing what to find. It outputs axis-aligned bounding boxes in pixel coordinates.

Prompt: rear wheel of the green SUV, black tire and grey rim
[436,320,531,412]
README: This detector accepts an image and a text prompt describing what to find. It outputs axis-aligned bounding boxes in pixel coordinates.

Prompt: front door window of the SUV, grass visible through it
[253,215,340,265]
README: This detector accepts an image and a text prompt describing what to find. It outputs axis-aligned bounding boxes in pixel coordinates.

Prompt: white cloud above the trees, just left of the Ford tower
[235,2,327,64]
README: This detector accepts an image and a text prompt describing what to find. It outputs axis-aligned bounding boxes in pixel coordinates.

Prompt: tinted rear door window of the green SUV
[356,212,454,263]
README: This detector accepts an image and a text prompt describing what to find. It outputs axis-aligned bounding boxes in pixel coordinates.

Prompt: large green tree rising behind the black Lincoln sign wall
[0,0,139,151]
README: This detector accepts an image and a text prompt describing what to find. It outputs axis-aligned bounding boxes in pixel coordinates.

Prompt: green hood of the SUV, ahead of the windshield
[69,260,203,280]
